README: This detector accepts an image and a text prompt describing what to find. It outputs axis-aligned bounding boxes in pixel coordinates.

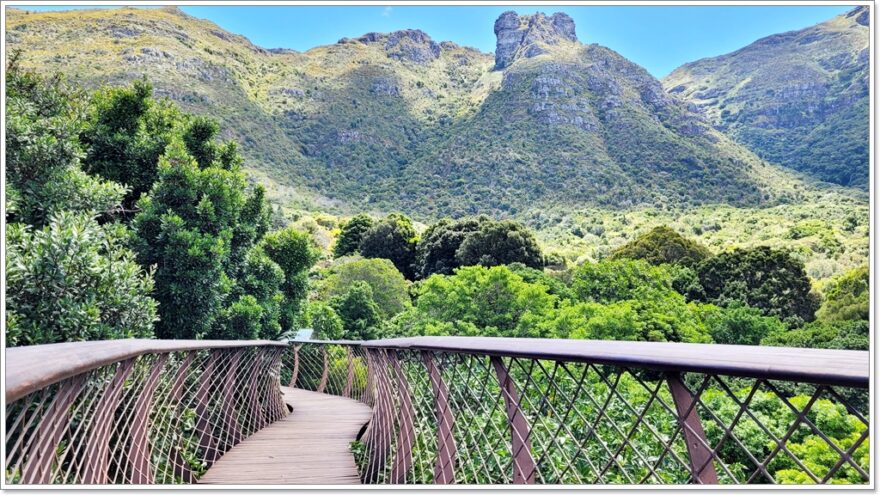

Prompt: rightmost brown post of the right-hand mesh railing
[666,373,718,485]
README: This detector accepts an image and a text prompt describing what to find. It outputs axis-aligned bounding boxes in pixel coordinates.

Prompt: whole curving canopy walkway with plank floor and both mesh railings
[4,337,871,485]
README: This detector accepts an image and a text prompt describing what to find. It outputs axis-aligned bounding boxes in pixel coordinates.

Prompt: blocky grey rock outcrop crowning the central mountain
[495,11,577,69]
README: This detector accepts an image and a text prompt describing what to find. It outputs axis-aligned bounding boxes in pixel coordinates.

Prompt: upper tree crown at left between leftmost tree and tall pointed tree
[82,79,180,204]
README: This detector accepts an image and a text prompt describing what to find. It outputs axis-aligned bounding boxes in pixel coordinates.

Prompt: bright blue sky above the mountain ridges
[15,4,852,77]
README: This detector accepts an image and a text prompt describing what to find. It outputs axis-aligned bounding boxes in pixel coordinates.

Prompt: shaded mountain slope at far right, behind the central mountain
[663,6,870,188]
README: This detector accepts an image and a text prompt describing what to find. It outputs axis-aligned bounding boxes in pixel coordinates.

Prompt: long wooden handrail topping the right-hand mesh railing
[362,336,871,388]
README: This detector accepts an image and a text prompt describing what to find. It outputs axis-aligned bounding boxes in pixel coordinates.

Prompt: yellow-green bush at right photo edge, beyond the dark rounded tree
[816,266,870,321]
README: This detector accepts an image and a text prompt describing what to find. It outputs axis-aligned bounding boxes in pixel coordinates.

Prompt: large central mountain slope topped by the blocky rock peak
[6,8,852,219]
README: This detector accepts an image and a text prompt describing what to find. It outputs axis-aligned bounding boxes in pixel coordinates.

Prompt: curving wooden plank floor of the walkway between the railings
[199,387,371,485]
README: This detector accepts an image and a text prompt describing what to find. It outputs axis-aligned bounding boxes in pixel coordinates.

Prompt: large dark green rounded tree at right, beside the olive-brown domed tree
[697,246,819,326]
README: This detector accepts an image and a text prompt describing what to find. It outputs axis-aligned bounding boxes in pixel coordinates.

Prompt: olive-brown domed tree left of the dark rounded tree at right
[611,225,712,266]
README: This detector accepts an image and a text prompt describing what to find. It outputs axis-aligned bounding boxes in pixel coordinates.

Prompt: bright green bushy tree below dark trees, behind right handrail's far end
[394,266,556,337]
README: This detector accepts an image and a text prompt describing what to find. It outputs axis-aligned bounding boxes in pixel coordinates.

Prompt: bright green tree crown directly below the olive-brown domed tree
[571,259,673,304]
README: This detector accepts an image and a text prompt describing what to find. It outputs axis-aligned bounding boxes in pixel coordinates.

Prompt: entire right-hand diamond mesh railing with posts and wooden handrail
[294,337,870,485]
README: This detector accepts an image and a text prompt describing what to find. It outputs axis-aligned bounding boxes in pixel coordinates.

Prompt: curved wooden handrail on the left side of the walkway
[4,339,287,403]
